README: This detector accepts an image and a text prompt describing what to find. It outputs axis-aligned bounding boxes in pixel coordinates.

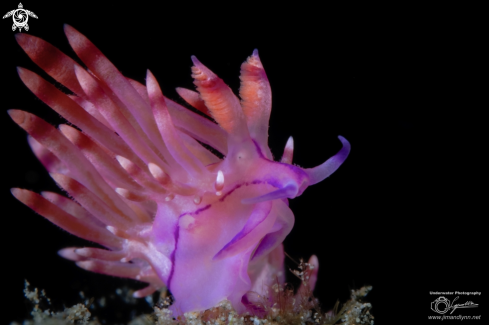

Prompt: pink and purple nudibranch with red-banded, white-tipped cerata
[9,25,350,314]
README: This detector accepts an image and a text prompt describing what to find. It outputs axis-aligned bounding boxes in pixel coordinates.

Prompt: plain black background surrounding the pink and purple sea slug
[0,1,487,324]
